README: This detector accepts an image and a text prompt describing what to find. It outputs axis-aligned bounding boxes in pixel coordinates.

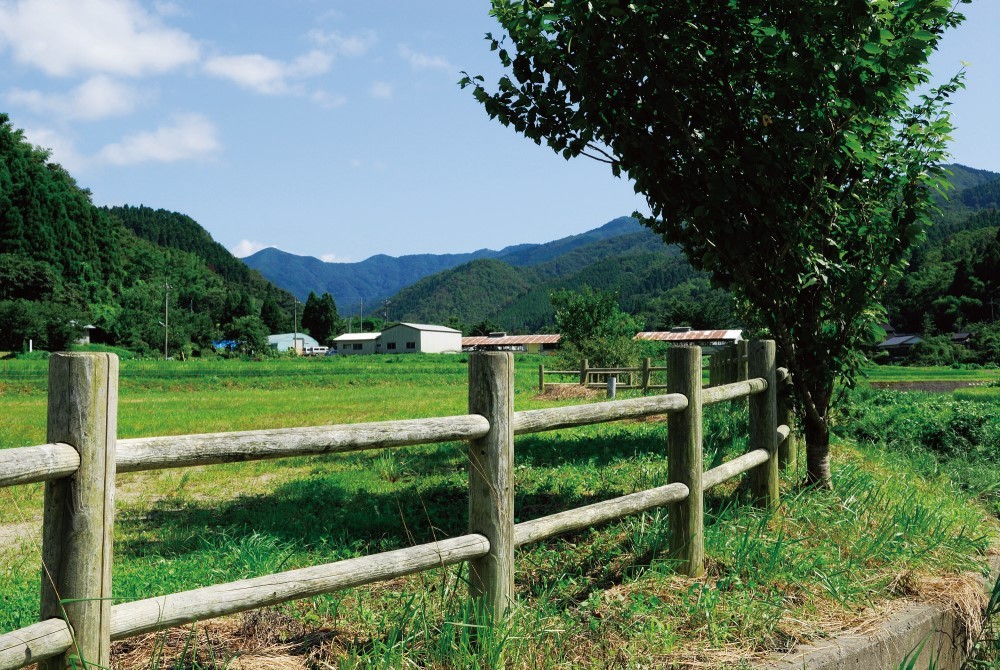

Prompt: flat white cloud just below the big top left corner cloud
[7,75,147,121]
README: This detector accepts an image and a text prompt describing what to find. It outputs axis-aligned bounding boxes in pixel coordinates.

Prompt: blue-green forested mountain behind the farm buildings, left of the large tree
[392,223,720,332]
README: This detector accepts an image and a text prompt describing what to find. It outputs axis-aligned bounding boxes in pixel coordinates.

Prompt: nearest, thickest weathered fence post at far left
[39,353,118,670]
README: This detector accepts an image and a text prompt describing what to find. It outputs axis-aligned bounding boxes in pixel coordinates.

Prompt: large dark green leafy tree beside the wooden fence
[462,0,968,483]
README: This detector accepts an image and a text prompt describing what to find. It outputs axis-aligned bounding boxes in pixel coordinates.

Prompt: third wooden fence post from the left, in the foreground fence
[667,347,705,577]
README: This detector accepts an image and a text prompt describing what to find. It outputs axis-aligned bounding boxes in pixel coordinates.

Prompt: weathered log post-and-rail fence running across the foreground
[0,341,791,670]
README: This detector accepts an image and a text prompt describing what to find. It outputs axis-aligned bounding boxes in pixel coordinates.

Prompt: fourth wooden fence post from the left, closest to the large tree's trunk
[748,340,779,509]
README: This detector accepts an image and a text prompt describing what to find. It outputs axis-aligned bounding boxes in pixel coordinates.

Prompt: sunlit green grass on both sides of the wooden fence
[0,356,996,668]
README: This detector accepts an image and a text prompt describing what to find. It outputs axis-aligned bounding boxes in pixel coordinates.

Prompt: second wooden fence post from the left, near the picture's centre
[469,353,514,619]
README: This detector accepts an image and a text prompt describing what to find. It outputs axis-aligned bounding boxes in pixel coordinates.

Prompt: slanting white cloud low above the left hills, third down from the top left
[97,114,222,165]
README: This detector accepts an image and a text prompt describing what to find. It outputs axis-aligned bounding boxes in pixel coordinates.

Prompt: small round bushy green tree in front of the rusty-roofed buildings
[550,287,642,367]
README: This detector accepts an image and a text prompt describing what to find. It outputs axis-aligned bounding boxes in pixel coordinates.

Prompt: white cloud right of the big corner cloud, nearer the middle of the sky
[205,50,333,95]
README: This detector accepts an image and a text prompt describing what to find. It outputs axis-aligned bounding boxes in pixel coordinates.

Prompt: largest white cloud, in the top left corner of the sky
[0,0,199,77]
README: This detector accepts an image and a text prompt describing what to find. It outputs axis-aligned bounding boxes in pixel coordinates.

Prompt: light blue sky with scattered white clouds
[0,0,1000,262]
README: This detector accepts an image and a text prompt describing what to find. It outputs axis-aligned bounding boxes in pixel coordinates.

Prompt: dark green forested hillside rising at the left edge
[0,114,292,353]
